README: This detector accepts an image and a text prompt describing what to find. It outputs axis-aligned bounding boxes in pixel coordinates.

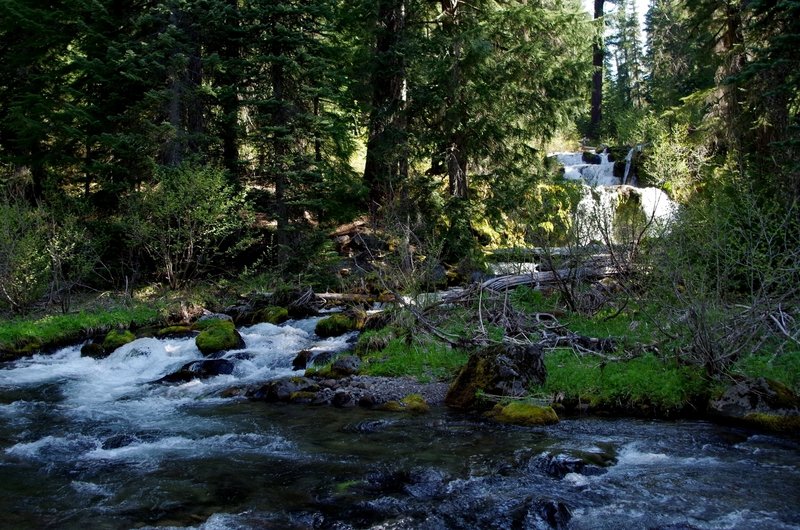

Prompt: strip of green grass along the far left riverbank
[0,305,162,353]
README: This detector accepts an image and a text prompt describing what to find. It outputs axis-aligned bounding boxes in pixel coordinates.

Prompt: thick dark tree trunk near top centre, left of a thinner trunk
[364,0,408,219]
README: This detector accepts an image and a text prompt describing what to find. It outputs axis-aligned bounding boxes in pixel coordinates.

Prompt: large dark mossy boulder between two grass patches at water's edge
[445,344,547,410]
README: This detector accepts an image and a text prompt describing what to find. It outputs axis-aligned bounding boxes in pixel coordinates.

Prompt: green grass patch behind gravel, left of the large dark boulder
[361,339,469,382]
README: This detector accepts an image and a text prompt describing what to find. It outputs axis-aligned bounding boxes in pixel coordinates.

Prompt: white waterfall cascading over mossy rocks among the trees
[552,146,677,244]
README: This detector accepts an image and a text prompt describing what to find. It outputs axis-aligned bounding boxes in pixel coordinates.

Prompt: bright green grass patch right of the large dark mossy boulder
[535,349,708,412]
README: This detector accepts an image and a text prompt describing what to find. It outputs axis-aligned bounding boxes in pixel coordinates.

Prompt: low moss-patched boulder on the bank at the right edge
[708,377,800,432]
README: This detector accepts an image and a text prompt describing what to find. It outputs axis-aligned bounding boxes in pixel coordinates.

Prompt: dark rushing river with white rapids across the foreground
[0,319,800,529]
